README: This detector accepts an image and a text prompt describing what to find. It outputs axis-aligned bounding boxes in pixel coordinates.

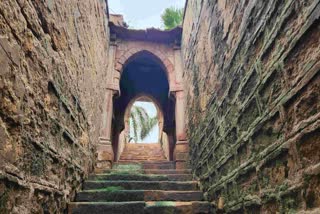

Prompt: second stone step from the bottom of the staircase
[76,189,203,202]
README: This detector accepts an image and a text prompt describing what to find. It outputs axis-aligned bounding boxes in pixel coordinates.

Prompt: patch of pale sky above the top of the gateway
[108,0,185,29]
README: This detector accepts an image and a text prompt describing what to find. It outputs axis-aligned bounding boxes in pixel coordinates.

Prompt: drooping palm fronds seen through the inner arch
[129,106,158,142]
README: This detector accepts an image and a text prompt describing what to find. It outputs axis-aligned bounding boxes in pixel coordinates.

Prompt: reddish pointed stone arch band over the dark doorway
[115,46,175,85]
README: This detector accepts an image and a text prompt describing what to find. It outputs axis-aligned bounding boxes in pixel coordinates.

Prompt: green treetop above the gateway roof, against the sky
[161,7,184,30]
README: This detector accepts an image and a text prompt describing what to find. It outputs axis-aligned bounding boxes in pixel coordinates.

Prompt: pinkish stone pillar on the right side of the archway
[173,47,189,169]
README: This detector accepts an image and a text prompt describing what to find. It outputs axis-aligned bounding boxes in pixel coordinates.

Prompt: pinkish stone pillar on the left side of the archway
[95,43,119,172]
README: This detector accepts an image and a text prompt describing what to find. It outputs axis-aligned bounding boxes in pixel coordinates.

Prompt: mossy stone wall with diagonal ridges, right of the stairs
[182,0,320,213]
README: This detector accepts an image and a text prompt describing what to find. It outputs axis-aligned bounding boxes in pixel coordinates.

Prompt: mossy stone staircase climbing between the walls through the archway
[68,144,212,214]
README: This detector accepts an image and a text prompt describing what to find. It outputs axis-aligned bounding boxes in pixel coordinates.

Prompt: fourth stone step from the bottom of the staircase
[89,172,192,181]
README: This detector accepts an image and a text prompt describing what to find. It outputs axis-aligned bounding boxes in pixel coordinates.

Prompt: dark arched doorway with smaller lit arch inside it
[112,51,175,160]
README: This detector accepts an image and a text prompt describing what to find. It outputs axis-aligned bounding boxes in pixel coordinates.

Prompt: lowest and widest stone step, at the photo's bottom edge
[68,201,214,214]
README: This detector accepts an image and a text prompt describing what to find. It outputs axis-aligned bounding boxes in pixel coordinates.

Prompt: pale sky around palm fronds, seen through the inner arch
[130,101,159,143]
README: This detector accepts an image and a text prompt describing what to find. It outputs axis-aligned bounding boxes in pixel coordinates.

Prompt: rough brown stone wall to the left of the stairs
[0,0,109,213]
